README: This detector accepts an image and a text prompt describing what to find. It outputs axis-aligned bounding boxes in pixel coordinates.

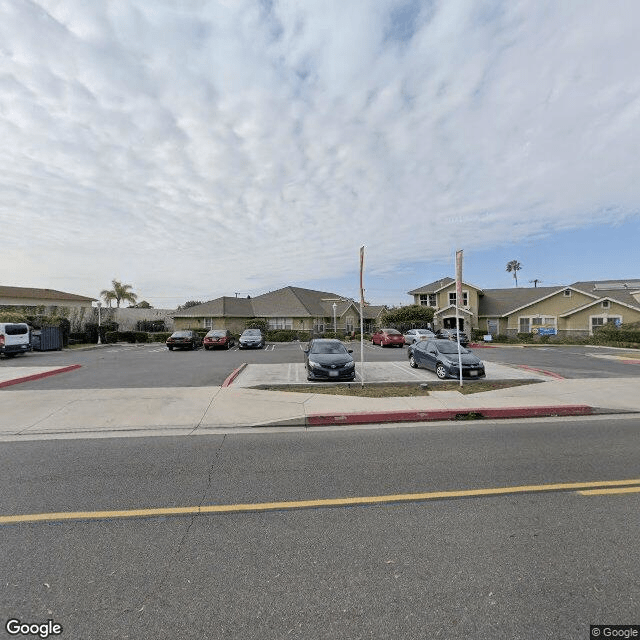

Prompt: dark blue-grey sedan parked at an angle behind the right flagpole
[408,339,485,380]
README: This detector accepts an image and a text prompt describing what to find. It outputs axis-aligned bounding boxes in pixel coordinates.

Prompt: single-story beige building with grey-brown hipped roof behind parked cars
[173,287,384,333]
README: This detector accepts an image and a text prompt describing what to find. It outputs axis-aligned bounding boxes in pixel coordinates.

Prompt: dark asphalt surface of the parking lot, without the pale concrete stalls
[0,343,640,389]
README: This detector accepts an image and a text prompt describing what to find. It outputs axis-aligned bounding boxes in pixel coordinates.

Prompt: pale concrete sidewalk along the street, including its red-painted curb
[0,370,640,441]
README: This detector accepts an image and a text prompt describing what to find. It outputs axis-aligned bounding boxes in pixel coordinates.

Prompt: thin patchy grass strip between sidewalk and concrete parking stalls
[256,380,540,398]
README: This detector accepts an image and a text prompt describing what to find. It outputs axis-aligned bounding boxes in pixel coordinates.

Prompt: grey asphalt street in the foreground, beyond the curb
[0,418,640,640]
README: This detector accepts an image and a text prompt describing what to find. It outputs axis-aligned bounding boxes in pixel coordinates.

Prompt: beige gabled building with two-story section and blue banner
[409,278,640,335]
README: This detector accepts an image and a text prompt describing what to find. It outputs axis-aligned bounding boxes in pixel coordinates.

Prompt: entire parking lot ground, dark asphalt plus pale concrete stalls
[0,342,640,392]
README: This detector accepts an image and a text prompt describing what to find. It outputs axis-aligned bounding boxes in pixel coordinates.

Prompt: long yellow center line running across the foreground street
[0,478,640,524]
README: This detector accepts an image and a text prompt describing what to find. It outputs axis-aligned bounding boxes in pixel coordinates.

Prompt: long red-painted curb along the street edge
[306,404,593,427]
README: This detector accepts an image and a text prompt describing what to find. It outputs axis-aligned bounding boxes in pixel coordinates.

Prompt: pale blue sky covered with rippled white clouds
[0,0,640,307]
